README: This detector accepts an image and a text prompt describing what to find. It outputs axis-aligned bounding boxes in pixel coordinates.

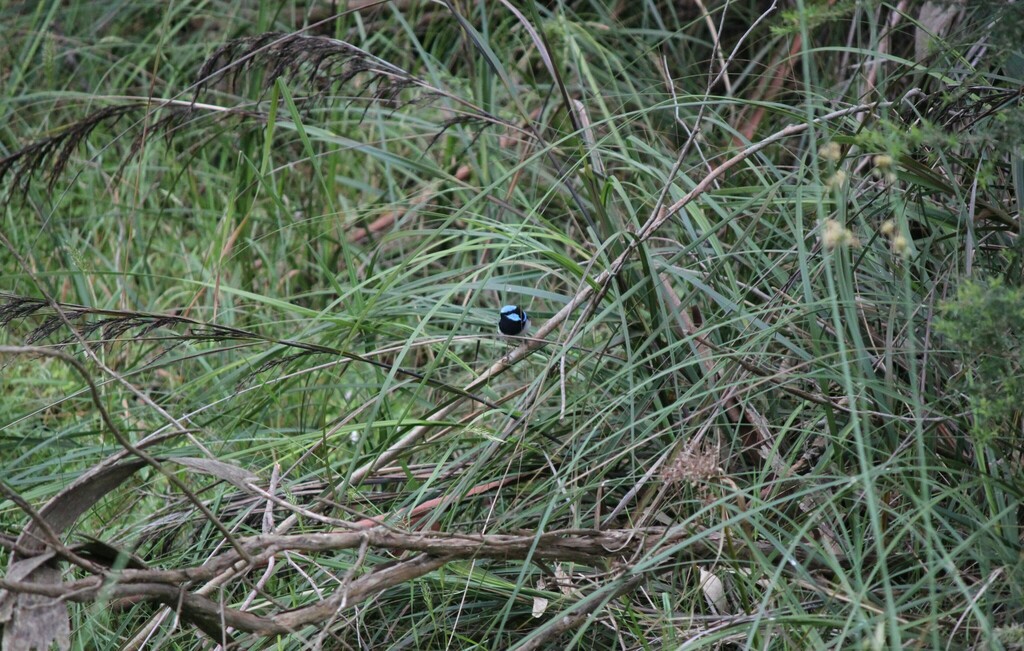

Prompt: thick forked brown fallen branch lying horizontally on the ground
[0,526,822,641]
